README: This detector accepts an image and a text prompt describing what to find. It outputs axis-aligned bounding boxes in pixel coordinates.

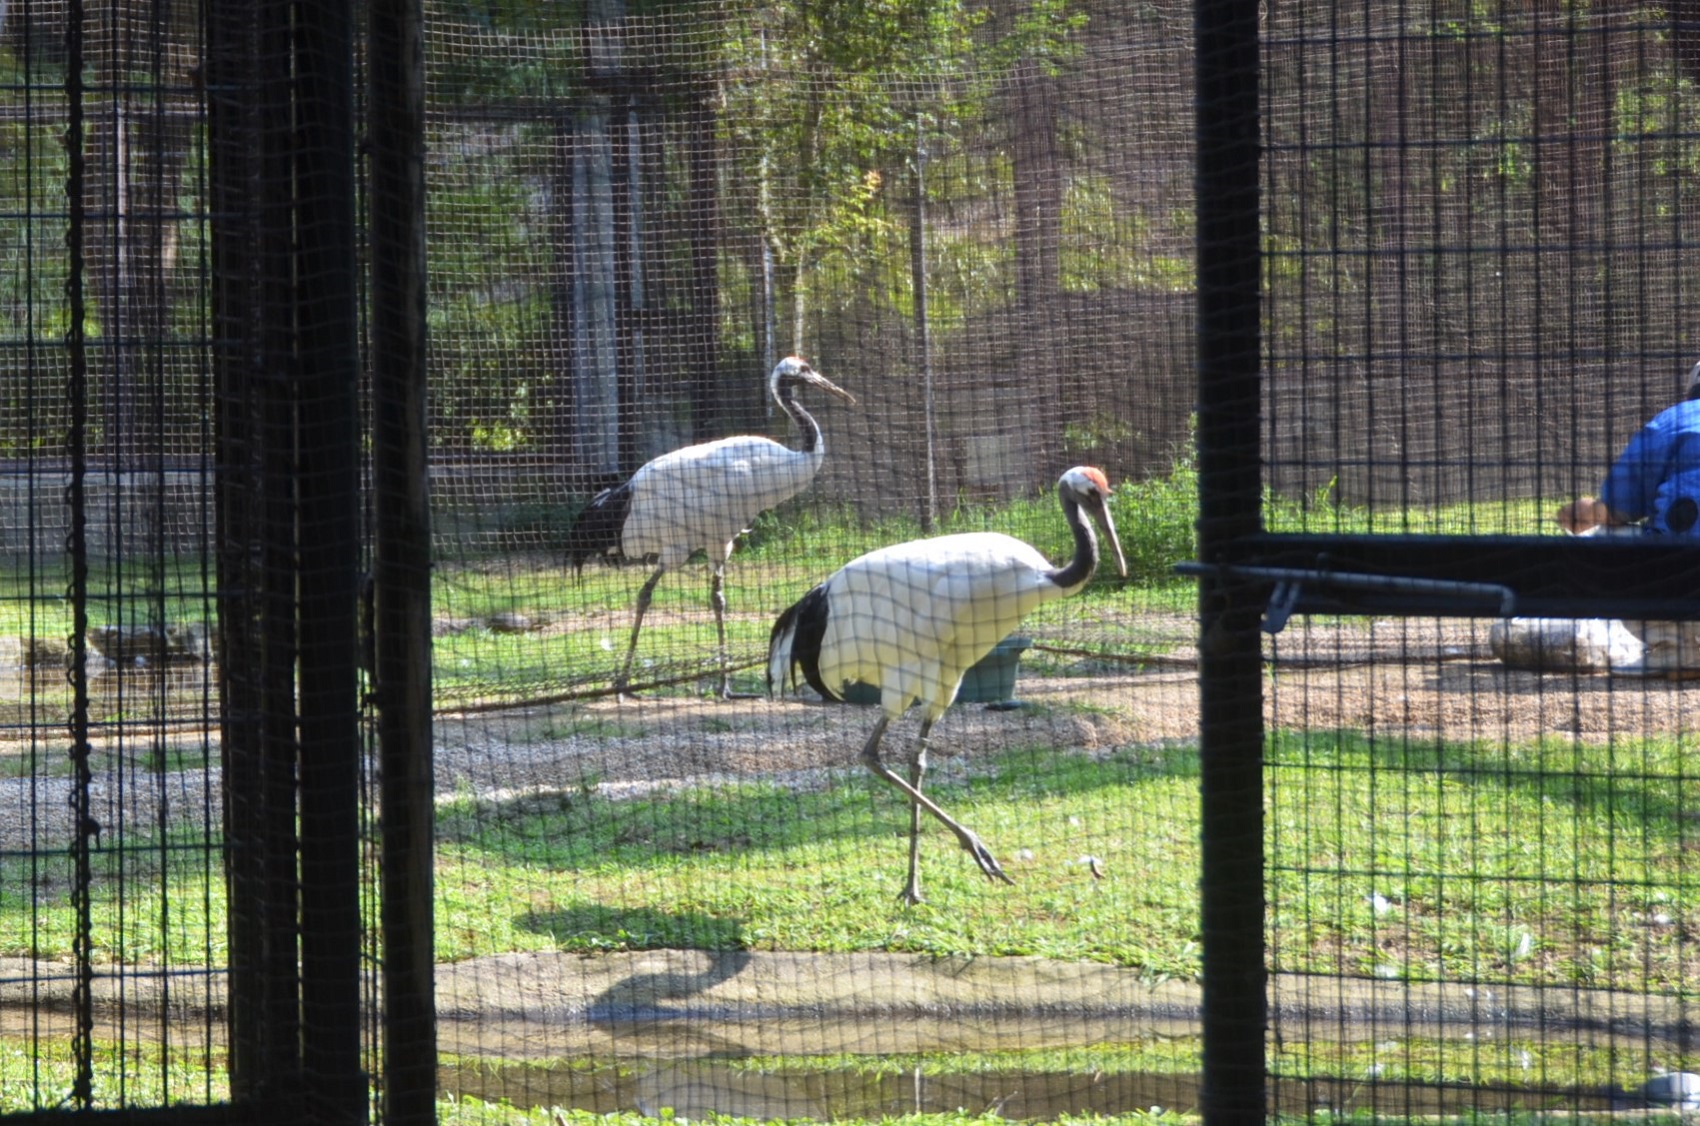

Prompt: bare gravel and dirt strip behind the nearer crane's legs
[437,616,1700,813]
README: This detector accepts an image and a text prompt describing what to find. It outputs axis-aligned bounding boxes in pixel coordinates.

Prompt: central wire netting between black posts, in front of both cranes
[428,5,1197,1119]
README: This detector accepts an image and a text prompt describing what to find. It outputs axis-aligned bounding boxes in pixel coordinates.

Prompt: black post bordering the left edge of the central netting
[367,0,437,1126]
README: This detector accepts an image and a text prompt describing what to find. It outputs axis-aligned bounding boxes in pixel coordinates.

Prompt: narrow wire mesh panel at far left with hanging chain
[0,5,226,1111]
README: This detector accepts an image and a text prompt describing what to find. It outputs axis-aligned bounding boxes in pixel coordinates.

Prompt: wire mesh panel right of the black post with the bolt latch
[1263,3,1700,1114]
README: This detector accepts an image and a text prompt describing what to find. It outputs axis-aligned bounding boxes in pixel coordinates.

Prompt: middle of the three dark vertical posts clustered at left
[292,0,369,1123]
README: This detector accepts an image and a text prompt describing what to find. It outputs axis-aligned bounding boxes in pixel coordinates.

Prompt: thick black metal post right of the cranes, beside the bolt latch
[1193,0,1268,1126]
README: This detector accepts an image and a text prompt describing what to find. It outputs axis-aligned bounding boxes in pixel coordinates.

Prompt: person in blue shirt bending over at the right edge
[1559,364,1700,675]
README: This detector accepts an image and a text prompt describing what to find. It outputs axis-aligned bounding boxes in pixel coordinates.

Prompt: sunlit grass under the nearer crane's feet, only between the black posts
[437,752,1197,976]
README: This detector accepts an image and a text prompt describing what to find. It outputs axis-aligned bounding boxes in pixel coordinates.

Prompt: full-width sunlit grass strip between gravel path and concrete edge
[0,731,1700,993]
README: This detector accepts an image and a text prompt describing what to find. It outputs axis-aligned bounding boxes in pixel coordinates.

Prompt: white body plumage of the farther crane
[619,434,826,566]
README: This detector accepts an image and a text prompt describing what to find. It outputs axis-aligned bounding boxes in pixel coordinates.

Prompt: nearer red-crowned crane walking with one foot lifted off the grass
[767,466,1127,903]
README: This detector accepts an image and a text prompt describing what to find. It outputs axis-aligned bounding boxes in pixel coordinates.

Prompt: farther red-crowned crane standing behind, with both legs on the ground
[566,355,855,697]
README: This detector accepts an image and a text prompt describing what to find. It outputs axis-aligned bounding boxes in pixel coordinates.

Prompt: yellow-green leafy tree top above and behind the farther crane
[721,0,1081,346]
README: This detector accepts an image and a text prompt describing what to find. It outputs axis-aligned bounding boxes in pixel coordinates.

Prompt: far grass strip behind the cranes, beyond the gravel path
[418,452,1557,706]
